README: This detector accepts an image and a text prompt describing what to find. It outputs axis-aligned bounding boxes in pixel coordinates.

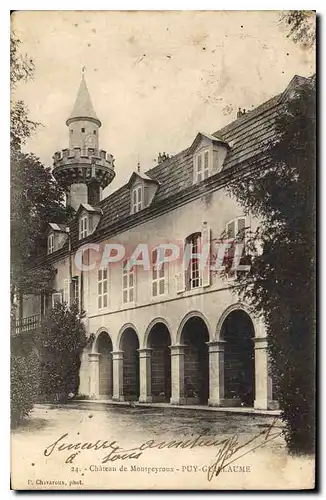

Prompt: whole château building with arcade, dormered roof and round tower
[17,75,310,409]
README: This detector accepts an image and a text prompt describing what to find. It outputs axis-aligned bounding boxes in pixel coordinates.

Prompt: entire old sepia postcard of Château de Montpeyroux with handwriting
[10,10,316,490]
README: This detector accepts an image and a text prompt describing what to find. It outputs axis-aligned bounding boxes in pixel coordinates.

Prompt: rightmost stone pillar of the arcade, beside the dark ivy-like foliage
[253,337,275,410]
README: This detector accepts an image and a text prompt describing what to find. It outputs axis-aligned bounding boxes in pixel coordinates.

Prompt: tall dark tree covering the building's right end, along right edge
[228,78,316,453]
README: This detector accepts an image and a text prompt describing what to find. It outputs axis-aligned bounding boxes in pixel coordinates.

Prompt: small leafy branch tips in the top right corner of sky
[281,10,316,48]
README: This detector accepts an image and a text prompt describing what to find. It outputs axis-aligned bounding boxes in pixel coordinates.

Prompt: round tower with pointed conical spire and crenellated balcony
[52,73,115,210]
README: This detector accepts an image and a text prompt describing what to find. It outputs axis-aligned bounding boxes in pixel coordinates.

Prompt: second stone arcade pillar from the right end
[207,340,225,406]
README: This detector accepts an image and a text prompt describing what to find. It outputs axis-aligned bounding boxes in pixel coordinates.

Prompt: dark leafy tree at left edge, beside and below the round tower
[11,151,74,294]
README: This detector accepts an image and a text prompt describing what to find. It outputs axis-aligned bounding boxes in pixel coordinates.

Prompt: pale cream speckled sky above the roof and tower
[12,11,315,196]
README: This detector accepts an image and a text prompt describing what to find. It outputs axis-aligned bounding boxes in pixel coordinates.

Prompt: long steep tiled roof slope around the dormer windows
[47,76,307,256]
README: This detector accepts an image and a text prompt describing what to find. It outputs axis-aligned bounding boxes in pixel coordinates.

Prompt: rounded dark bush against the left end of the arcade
[37,304,87,402]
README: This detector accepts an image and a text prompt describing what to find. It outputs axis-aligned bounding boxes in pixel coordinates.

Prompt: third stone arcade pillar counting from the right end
[170,344,186,405]
